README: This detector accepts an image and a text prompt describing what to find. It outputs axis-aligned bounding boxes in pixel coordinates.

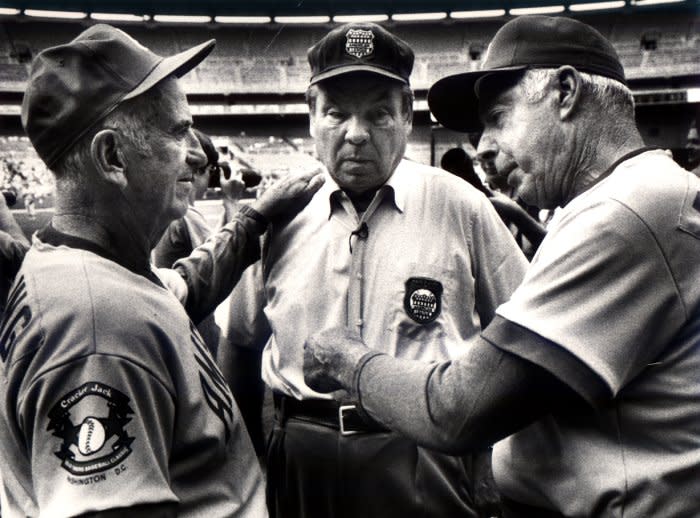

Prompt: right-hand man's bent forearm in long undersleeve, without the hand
[355,339,570,454]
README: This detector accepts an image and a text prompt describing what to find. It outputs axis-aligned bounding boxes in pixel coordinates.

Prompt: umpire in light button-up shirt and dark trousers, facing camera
[180,23,526,518]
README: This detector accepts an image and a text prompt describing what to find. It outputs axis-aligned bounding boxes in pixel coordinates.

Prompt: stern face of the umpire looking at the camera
[310,73,412,194]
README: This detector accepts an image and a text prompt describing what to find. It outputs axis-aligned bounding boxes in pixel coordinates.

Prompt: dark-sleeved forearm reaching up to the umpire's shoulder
[173,212,265,323]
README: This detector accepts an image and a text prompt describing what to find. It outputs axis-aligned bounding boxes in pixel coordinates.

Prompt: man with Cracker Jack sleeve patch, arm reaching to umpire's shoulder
[0,25,320,517]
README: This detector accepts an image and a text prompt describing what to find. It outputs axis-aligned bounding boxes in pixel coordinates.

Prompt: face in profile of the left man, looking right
[117,79,206,234]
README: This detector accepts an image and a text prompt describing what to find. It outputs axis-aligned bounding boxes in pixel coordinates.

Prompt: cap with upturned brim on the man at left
[22,24,215,167]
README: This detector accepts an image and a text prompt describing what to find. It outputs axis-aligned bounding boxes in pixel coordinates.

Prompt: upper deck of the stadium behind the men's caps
[0,11,700,95]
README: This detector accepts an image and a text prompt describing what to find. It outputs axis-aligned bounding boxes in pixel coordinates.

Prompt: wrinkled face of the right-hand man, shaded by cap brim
[477,77,569,209]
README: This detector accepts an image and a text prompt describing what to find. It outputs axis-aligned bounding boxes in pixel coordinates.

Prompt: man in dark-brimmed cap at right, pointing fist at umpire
[306,16,700,517]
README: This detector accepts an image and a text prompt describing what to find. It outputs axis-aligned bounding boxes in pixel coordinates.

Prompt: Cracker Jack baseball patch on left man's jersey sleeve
[47,381,134,476]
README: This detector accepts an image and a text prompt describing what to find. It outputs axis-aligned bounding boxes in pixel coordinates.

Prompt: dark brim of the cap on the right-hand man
[428,66,527,133]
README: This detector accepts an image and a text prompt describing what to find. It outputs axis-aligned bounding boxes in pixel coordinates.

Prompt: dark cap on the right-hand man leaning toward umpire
[428,15,626,132]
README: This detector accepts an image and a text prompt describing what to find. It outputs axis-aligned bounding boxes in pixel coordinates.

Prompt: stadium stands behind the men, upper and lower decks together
[0,11,700,203]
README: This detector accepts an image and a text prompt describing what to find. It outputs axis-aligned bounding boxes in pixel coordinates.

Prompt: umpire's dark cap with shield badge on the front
[307,23,414,85]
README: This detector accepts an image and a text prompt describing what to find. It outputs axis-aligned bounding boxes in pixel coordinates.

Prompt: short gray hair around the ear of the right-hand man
[519,68,634,117]
